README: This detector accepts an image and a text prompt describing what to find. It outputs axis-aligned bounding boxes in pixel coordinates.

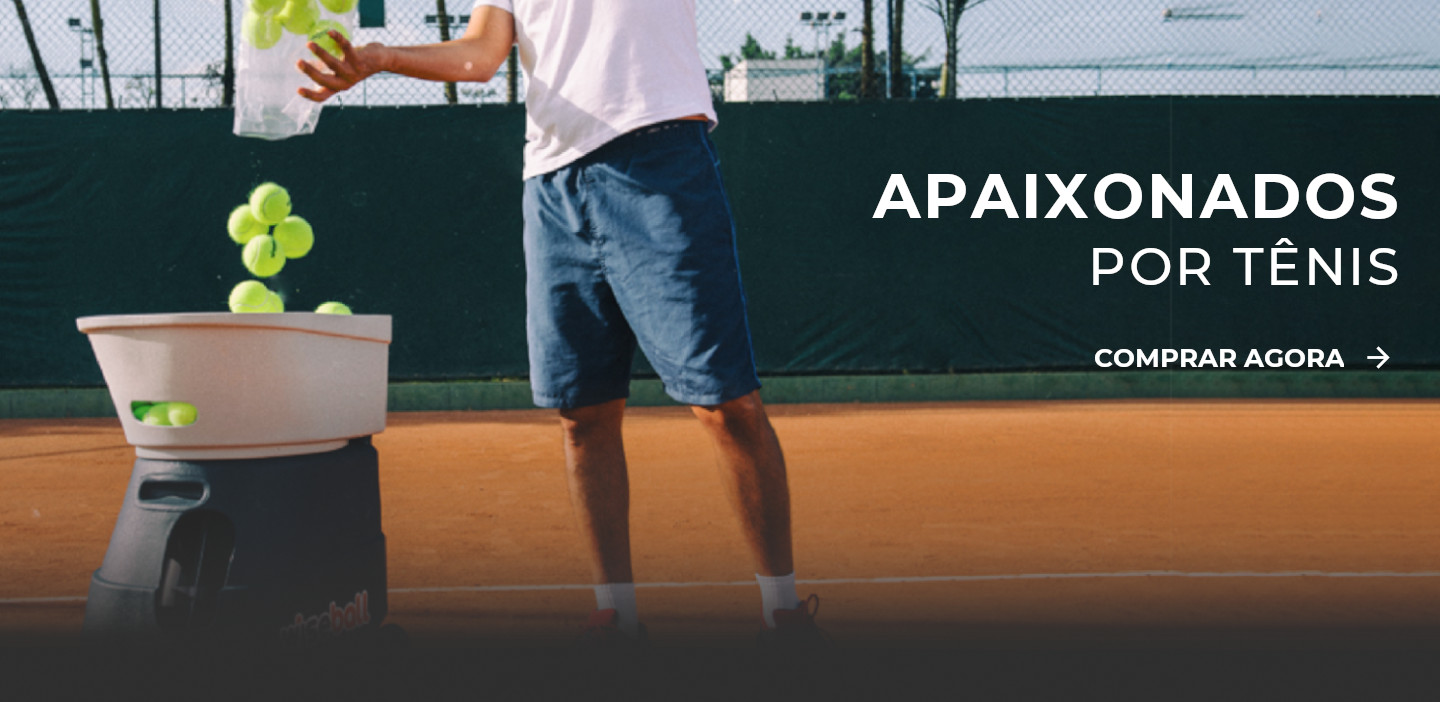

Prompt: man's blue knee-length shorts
[524,121,760,409]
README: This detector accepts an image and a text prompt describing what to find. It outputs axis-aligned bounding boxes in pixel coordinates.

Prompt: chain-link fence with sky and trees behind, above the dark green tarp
[0,0,1440,109]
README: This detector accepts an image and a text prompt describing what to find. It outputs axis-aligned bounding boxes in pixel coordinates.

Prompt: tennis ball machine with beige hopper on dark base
[76,312,390,643]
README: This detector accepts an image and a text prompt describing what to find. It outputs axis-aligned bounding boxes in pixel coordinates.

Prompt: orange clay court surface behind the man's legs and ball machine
[0,400,1440,693]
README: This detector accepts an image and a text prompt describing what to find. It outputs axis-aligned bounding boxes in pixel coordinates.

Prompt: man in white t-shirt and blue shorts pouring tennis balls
[300,0,818,642]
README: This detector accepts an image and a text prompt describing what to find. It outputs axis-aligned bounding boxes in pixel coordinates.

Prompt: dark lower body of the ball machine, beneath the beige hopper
[85,437,387,640]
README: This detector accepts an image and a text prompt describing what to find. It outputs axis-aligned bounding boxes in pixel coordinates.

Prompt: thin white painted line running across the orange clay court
[11,571,1440,606]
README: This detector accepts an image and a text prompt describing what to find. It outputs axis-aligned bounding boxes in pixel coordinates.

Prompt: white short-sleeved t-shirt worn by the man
[475,0,716,178]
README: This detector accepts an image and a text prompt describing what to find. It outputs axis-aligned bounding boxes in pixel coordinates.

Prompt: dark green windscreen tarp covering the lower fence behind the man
[0,98,1440,387]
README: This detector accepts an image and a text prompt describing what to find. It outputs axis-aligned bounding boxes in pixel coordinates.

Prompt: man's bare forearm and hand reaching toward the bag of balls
[298,6,516,102]
